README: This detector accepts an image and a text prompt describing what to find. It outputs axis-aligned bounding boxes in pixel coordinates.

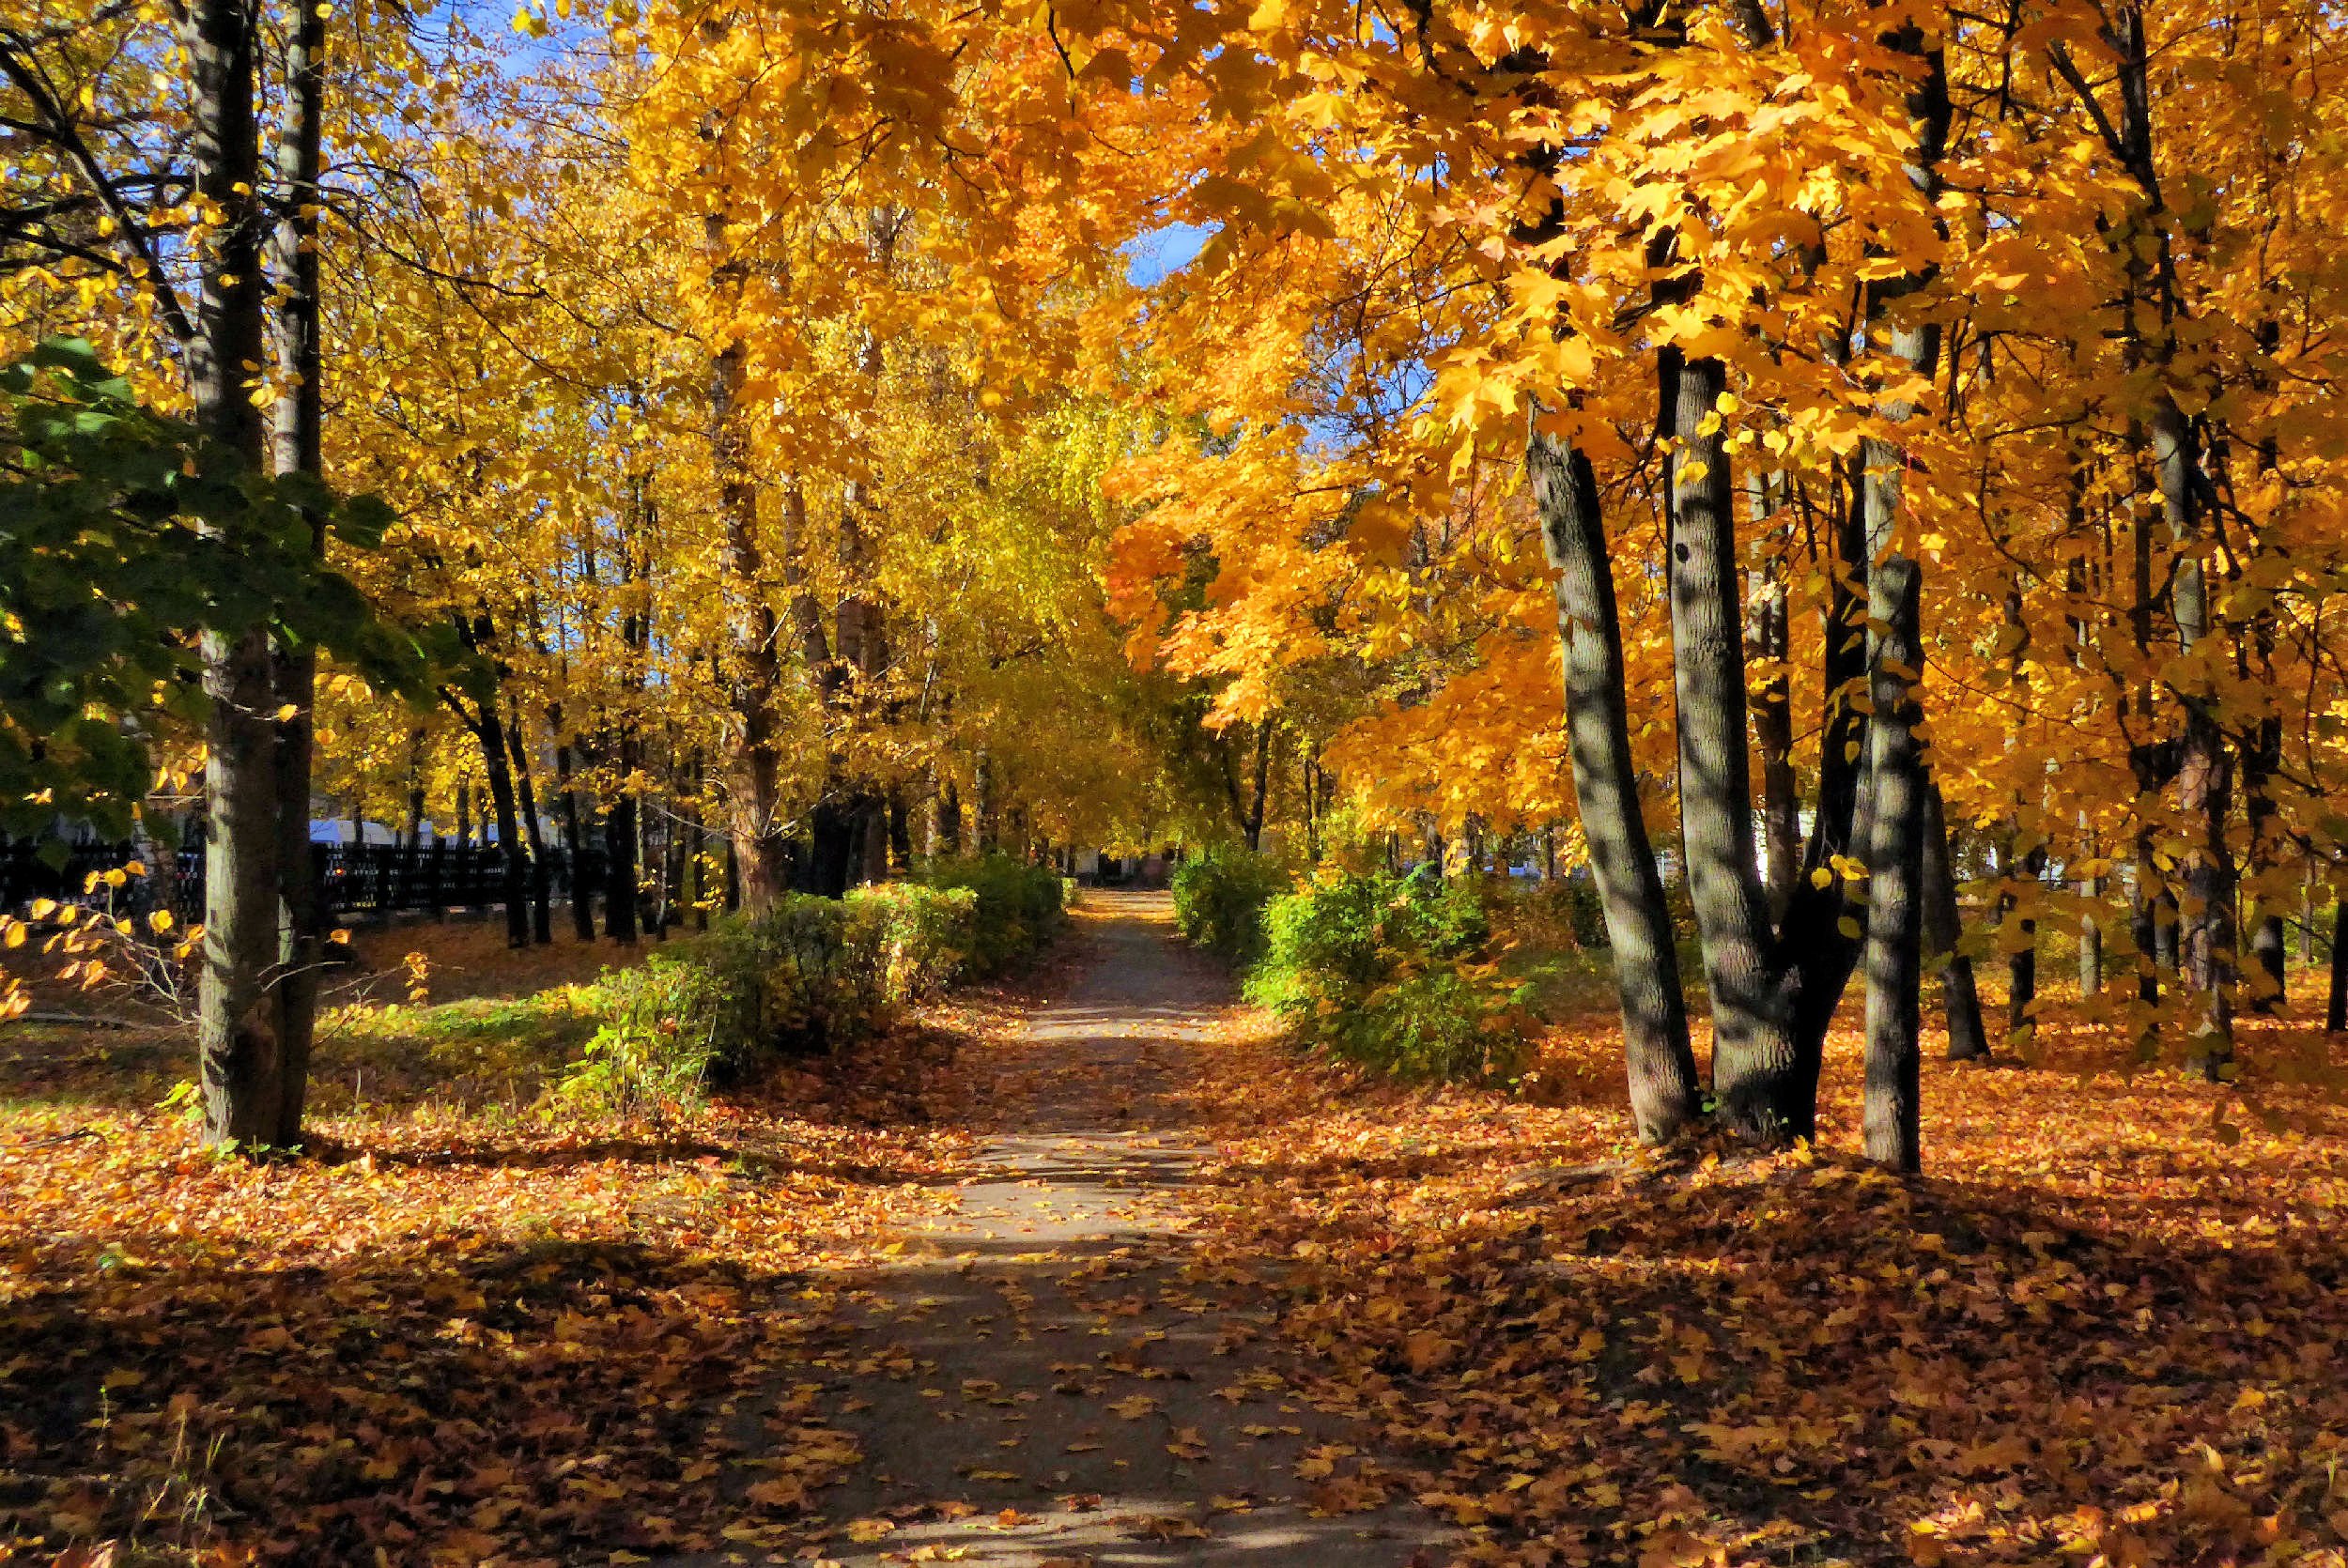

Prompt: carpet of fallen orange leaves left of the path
[0,925,967,1568]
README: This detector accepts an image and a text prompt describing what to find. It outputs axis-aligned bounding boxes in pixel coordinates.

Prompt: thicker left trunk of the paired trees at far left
[181,0,279,1148]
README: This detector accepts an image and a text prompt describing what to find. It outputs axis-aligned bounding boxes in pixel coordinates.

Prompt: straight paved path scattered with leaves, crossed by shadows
[798,892,1449,1568]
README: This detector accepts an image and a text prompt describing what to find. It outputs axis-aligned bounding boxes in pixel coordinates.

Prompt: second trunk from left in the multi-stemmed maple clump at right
[1670,360,1817,1144]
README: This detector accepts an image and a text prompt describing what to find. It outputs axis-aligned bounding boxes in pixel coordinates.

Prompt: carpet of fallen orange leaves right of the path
[1197,1019,2348,1568]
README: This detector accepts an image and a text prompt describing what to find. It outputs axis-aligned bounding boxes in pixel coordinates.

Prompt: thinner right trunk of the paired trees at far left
[270,5,327,1148]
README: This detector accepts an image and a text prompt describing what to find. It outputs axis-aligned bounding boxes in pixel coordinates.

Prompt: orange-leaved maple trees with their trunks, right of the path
[1099,0,2348,1167]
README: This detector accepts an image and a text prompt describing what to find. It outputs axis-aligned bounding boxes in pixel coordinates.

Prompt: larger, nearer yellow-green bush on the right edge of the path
[1247,869,1529,1083]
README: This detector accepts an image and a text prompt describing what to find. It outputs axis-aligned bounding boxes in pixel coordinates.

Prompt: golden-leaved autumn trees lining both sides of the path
[0,0,2348,1167]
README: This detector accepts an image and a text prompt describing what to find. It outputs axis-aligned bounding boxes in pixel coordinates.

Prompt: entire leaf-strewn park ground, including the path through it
[0,895,2348,1568]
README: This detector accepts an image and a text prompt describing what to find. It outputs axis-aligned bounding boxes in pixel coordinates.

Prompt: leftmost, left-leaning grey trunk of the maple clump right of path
[1526,407,1703,1144]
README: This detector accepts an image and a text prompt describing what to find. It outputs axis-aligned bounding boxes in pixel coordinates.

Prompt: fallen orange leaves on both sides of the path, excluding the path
[0,906,2348,1568]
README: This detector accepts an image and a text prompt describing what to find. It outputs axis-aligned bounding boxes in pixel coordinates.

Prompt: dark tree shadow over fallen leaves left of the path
[0,1237,850,1563]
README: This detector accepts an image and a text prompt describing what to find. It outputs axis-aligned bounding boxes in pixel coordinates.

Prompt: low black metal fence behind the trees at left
[0,840,604,923]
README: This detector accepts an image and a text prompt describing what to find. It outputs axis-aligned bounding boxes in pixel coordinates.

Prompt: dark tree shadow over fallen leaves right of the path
[1243,1141,2348,1563]
